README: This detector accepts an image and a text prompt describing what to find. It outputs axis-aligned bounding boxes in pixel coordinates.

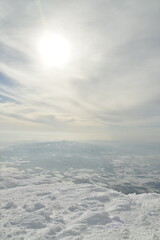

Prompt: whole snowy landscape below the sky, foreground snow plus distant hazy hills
[0,142,160,240]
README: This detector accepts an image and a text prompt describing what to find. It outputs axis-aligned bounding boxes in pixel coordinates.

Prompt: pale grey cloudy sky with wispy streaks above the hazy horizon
[0,0,160,142]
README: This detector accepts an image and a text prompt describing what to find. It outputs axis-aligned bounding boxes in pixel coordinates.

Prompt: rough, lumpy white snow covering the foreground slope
[0,168,160,240]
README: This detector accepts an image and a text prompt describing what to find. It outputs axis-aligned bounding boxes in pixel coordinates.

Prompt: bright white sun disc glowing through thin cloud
[37,32,71,67]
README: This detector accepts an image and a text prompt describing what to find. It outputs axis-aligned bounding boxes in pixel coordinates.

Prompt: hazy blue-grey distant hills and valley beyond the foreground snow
[0,141,160,194]
